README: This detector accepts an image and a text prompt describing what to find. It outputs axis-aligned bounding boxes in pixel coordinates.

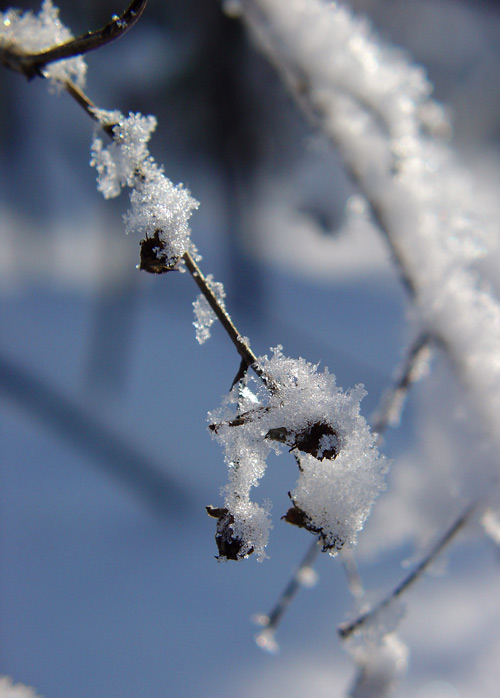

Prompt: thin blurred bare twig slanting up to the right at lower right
[338,503,477,639]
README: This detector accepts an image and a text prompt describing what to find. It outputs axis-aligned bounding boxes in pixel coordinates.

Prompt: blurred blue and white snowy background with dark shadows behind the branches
[0,0,500,698]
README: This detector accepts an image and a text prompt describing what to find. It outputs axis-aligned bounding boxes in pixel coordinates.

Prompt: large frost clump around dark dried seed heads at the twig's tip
[209,347,387,559]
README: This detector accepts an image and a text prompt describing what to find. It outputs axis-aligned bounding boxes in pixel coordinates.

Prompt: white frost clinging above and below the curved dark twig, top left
[0,0,87,89]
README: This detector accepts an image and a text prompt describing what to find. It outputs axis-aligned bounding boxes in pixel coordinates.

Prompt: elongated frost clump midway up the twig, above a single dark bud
[90,110,199,264]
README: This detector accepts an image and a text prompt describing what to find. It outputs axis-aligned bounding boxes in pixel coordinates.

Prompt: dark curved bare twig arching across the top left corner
[0,0,147,80]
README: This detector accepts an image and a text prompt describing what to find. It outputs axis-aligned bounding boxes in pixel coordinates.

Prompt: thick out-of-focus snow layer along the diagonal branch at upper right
[242,0,500,524]
